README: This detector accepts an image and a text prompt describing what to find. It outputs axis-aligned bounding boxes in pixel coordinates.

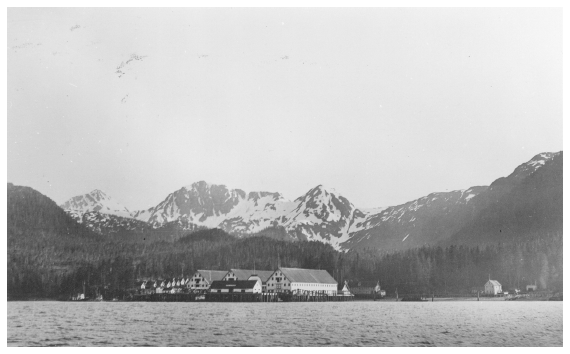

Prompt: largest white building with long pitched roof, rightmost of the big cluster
[267,267,338,295]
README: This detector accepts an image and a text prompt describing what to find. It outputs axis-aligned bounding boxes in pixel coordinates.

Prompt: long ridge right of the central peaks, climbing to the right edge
[341,152,562,250]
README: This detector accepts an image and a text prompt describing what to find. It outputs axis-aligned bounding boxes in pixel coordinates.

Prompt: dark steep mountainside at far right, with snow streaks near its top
[447,152,564,245]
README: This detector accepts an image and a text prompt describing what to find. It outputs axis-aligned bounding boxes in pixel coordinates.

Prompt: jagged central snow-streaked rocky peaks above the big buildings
[133,181,366,248]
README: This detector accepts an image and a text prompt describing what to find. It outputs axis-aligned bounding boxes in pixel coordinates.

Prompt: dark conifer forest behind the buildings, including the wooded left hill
[7,184,563,299]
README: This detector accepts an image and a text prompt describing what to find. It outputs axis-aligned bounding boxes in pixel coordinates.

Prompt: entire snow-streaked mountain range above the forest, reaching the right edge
[60,152,563,251]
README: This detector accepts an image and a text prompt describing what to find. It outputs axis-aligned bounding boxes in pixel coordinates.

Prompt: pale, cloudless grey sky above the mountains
[7,8,563,210]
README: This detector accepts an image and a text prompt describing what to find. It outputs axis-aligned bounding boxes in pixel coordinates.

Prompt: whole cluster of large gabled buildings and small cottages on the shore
[136,267,339,295]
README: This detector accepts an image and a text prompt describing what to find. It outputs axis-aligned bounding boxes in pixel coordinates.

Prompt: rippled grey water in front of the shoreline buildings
[8,301,562,346]
